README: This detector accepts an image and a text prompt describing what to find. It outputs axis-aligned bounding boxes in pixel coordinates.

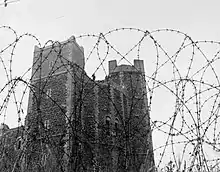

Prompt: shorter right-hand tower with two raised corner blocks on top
[108,59,155,171]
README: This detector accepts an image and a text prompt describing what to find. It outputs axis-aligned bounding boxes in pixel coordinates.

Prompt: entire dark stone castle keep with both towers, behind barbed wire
[0,37,154,172]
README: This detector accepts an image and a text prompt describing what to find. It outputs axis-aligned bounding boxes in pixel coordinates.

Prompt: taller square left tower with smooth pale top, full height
[25,37,85,171]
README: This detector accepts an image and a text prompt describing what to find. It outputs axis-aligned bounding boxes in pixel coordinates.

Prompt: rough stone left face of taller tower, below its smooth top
[26,74,67,171]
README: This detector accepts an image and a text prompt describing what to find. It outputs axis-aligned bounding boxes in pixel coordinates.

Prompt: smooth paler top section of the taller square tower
[32,36,85,80]
